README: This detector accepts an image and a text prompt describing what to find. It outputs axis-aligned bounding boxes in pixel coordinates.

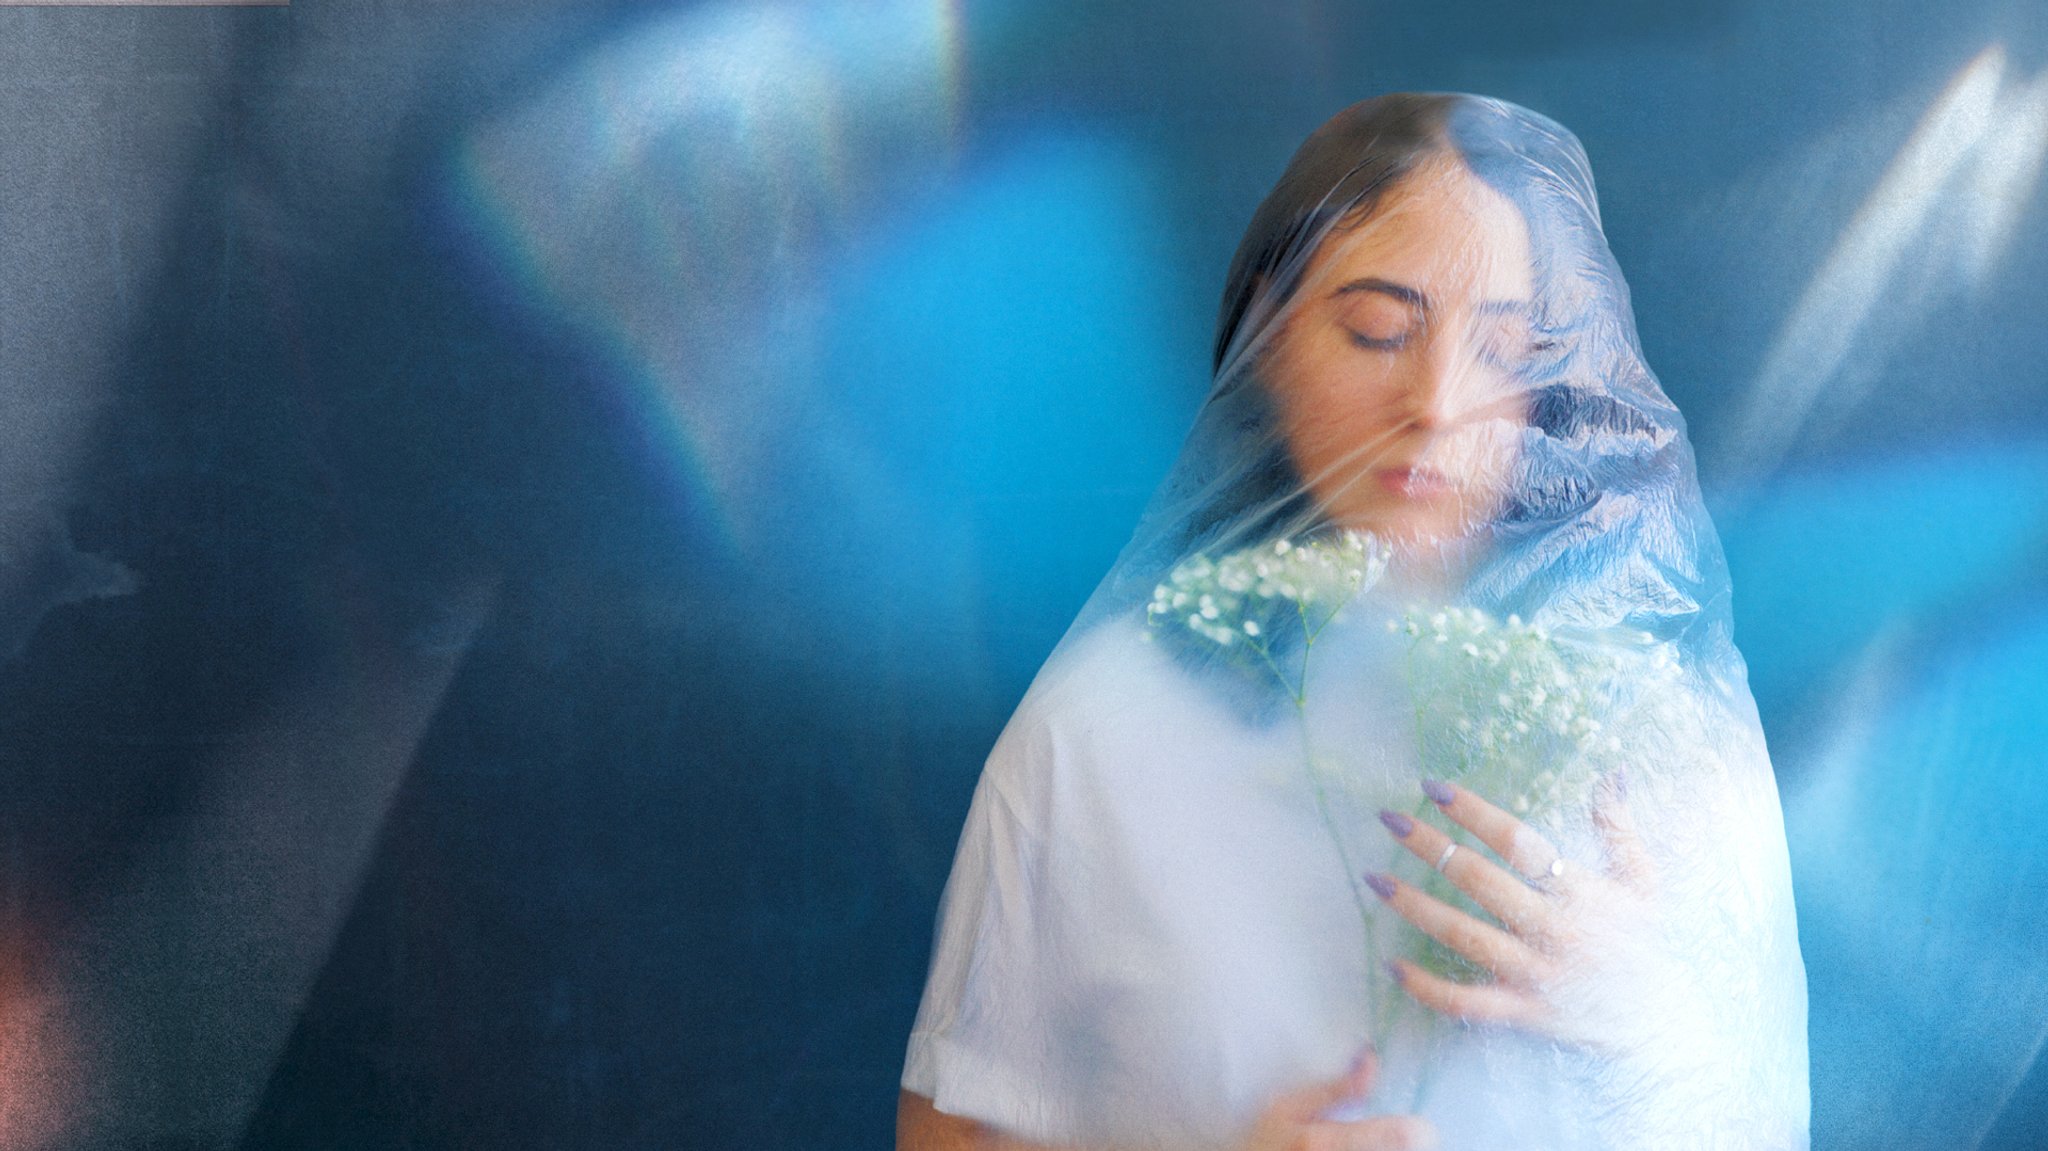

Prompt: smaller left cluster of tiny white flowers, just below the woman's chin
[1145,530,1389,647]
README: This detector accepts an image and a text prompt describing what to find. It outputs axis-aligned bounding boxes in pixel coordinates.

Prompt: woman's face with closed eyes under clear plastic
[1264,156,1532,543]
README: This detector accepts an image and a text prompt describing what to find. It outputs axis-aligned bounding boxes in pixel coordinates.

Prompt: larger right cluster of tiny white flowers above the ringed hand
[1386,606,1679,817]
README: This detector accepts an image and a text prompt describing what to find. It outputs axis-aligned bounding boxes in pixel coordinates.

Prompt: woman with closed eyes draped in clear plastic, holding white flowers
[899,94,1808,1151]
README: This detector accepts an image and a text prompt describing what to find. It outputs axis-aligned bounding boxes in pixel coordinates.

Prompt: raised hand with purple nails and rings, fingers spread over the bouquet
[1366,778,1690,1053]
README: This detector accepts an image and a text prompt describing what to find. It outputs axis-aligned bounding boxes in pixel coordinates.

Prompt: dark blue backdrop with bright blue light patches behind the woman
[0,0,2048,1151]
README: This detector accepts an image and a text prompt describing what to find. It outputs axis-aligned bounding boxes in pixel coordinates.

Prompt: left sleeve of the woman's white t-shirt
[901,696,1075,1141]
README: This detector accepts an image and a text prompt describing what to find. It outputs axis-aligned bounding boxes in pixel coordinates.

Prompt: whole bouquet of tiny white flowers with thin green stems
[1145,530,1677,1044]
